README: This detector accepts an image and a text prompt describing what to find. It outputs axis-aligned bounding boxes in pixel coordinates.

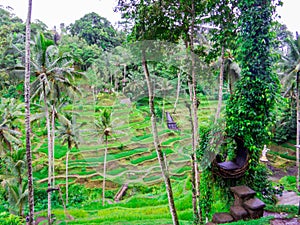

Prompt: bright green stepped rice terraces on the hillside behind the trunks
[36,85,216,192]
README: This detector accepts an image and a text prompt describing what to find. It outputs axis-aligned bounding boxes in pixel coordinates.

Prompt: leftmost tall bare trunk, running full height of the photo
[24,0,34,222]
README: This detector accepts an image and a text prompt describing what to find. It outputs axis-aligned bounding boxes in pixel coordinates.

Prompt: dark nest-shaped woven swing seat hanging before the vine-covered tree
[212,137,250,179]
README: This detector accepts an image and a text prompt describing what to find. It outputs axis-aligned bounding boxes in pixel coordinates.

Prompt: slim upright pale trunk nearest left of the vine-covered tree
[190,0,201,222]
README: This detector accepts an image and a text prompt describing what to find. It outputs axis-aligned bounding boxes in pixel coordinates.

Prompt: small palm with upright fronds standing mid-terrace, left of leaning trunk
[94,109,111,206]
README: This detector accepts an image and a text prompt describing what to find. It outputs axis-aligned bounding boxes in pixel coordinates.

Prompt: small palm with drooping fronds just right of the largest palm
[58,113,86,206]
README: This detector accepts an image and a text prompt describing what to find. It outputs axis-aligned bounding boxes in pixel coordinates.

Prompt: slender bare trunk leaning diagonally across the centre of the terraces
[142,50,179,225]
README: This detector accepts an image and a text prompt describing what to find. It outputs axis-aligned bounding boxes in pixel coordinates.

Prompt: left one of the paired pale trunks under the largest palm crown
[42,80,52,224]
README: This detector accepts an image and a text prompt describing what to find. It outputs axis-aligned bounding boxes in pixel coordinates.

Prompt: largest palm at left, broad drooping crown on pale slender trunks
[31,34,83,223]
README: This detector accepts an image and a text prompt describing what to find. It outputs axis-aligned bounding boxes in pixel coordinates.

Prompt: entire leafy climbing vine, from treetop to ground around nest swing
[198,0,281,219]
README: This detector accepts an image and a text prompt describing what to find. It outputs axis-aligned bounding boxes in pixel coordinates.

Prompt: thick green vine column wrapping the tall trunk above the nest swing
[226,0,279,153]
